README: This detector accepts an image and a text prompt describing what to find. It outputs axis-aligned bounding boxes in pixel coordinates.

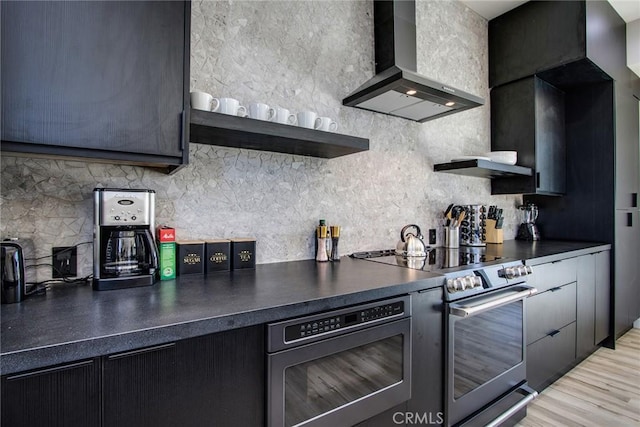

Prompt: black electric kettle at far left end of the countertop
[0,242,26,304]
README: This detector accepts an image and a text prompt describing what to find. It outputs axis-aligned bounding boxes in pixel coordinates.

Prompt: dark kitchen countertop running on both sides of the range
[0,240,611,375]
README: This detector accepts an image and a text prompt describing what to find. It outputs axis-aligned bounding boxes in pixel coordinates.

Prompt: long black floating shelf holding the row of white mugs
[190,110,369,159]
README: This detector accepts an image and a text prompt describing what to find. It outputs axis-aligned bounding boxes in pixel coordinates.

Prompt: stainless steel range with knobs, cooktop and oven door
[351,247,537,426]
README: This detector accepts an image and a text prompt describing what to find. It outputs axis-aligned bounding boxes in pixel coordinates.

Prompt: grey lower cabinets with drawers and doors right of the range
[527,250,611,391]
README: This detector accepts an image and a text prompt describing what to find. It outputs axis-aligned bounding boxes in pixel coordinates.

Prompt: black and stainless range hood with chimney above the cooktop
[342,0,484,122]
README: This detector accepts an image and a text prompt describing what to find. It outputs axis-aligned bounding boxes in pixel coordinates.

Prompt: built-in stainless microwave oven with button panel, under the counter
[267,296,411,427]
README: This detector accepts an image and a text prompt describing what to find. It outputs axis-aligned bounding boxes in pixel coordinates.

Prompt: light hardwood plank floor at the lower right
[517,329,640,427]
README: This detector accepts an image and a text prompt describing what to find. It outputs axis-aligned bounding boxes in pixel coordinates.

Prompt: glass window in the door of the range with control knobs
[453,301,524,399]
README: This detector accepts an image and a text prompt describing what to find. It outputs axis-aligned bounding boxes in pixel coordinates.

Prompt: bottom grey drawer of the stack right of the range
[527,322,576,391]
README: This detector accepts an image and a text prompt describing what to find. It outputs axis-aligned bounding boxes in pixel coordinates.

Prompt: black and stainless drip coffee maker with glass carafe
[93,188,158,291]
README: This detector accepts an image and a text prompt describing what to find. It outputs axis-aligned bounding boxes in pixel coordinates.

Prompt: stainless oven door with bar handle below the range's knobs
[446,285,535,425]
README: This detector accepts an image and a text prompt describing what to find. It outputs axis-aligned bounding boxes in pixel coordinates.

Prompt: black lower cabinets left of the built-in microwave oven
[1,326,265,427]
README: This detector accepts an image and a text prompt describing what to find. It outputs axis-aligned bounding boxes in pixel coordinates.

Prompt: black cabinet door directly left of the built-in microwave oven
[174,326,266,427]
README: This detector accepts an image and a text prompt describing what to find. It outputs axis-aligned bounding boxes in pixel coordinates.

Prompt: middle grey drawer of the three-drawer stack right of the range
[527,282,577,344]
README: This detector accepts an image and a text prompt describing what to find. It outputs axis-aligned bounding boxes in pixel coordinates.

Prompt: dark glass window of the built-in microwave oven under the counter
[284,335,404,426]
